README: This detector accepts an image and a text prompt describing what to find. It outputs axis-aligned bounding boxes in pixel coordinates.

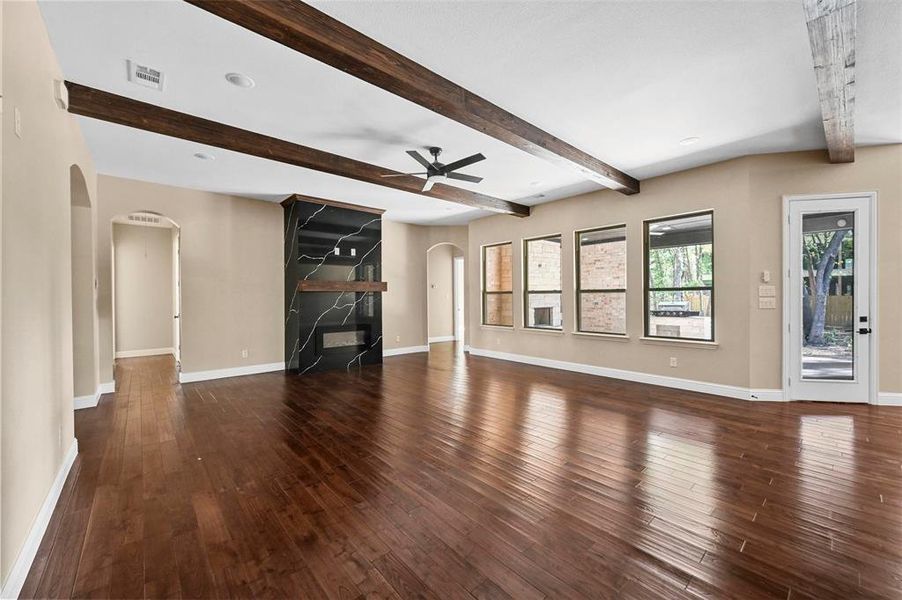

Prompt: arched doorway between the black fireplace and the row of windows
[426,242,466,350]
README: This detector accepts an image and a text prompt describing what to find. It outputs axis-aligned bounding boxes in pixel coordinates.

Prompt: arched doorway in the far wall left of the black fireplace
[110,210,182,373]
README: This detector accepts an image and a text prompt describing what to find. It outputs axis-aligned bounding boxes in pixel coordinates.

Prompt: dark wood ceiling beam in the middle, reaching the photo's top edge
[180,0,639,194]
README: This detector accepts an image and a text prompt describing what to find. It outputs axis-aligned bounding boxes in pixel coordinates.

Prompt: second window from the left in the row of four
[523,235,561,329]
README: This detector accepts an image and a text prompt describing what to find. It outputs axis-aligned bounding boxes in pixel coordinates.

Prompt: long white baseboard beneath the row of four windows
[470,346,783,402]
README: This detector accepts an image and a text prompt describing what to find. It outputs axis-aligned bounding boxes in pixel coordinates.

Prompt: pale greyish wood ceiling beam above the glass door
[803,0,857,163]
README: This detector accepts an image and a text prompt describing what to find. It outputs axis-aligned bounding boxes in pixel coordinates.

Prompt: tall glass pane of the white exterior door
[801,212,855,381]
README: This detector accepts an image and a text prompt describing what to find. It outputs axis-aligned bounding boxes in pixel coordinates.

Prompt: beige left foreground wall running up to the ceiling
[0,2,96,583]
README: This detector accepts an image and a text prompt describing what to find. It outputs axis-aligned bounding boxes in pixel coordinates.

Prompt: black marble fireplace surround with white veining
[282,196,382,374]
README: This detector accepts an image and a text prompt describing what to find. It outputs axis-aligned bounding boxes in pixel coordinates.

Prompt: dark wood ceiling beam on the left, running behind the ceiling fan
[66,81,529,217]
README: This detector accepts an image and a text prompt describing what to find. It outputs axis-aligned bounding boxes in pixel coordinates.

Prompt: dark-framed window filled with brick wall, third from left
[576,225,626,335]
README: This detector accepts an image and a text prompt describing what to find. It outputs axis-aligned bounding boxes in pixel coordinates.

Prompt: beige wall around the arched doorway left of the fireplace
[97,176,285,381]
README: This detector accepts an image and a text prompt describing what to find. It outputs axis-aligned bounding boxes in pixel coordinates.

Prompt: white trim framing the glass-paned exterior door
[780,192,880,404]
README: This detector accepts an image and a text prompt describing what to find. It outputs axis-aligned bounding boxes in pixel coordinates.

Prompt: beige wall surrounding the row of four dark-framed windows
[469,156,749,386]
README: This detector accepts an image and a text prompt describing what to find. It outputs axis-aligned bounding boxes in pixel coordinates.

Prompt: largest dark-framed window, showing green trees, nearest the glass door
[645,212,714,341]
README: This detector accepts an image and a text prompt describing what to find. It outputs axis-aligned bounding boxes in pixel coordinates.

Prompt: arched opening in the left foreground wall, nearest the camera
[69,165,97,408]
